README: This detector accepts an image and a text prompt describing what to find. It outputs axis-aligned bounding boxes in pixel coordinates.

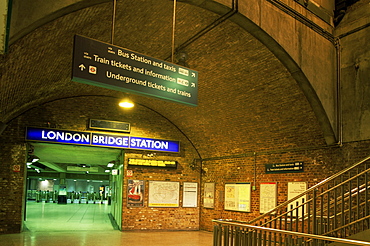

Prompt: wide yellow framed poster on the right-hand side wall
[224,183,251,212]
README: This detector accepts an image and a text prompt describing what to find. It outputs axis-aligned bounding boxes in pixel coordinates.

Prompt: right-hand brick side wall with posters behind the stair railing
[200,141,370,231]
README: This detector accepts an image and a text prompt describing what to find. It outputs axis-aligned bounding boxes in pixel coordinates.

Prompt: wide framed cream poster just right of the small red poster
[148,181,180,208]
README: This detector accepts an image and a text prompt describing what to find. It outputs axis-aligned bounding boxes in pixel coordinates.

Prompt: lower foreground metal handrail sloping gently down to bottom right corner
[212,220,370,246]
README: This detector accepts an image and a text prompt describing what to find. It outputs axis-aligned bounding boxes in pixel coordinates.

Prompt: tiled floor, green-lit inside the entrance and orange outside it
[0,202,212,246]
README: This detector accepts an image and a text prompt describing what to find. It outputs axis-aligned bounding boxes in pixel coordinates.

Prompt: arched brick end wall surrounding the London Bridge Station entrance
[0,97,200,233]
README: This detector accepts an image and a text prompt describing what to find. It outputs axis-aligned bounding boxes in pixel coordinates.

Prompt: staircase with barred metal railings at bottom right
[213,156,370,246]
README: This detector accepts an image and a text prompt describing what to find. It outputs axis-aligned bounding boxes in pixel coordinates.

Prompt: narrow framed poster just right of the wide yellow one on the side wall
[260,182,277,214]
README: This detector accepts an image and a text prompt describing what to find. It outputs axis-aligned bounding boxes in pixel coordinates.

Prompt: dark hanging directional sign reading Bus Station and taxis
[72,35,198,106]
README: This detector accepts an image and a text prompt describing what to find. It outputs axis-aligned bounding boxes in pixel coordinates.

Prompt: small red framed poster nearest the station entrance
[127,179,145,207]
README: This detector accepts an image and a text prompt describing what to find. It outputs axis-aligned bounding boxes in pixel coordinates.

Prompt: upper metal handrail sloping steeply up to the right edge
[248,156,370,224]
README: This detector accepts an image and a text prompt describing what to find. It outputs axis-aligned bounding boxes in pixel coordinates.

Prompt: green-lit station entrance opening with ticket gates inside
[24,142,124,231]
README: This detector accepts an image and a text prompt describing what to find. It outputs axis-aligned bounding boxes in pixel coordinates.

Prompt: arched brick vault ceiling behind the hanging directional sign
[0,0,325,158]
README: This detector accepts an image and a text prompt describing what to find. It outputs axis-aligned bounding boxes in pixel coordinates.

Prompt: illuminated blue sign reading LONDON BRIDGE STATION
[26,127,180,152]
